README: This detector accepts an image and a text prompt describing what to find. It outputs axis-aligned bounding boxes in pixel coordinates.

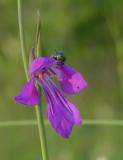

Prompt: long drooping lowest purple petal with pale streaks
[39,75,81,138]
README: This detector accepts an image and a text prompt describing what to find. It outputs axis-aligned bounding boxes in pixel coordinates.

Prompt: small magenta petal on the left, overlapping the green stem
[15,80,40,106]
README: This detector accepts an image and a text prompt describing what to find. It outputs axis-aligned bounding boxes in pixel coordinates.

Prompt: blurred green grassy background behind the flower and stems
[0,0,123,160]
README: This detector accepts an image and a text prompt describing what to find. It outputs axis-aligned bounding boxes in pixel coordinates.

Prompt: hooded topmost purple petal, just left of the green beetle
[29,57,58,76]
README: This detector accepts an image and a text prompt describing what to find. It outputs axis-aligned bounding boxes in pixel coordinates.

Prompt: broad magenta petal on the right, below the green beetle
[53,65,88,95]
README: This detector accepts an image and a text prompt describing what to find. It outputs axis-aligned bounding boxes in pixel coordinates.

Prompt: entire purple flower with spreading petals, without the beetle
[15,54,88,138]
